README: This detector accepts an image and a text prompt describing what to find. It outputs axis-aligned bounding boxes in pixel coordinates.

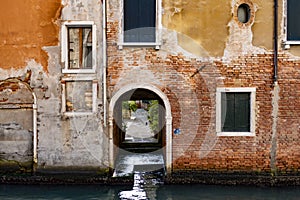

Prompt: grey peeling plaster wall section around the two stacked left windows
[38,0,108,171]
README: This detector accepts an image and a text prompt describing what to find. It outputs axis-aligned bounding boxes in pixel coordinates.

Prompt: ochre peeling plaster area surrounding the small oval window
[163,0,273,57]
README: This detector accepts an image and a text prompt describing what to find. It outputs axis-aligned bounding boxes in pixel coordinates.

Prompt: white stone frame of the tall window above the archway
[118,0,162,49]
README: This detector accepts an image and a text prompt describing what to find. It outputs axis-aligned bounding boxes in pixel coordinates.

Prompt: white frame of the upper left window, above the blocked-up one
[61,21,97,74]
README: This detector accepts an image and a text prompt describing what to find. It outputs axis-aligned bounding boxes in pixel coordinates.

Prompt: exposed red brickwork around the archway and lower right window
[108,2,300,172]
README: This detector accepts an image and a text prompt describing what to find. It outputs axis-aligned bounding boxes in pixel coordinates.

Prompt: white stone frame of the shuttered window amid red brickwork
[216,87,256,136]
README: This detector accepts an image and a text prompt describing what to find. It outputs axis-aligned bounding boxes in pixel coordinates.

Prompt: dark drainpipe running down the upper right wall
[273,0,278,85]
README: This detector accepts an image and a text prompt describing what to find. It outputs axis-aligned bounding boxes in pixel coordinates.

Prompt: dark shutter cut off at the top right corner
[287,0,300,41]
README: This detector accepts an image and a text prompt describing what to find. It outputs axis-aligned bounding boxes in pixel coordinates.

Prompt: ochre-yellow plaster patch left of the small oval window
[163,0,232,56]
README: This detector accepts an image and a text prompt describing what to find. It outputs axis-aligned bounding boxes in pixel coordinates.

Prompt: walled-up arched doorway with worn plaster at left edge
[0,79,33,166]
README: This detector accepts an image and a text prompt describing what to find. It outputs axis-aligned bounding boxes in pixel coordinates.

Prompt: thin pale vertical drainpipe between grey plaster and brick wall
[102,0,107,127]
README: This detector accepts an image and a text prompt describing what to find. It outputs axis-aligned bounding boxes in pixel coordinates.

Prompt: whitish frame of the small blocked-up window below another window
[61,77,98,116]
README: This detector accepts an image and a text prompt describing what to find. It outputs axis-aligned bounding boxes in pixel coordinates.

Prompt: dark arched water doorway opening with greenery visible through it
[114,89,165,152]
